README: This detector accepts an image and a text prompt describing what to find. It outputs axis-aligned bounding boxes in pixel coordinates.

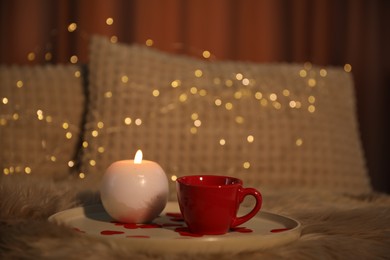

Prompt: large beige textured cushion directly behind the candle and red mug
[82,37,370,198]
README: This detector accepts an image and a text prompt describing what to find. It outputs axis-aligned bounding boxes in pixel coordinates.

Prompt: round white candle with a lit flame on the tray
[100,150,169,223]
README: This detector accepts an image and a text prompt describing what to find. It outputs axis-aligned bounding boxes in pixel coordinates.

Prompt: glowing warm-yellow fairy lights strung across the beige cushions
[0,17,352,181]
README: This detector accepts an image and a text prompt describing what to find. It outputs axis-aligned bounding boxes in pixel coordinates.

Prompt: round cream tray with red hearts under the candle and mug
[49,202,301,253]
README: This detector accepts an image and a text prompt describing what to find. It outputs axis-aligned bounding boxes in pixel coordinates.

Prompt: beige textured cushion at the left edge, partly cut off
[0,65,85,178]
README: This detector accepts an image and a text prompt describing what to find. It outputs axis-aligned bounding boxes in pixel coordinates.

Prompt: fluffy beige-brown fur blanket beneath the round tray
[0,176,390,259]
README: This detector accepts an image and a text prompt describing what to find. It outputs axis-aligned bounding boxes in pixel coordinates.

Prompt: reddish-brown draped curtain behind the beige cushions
[0,0,390,193]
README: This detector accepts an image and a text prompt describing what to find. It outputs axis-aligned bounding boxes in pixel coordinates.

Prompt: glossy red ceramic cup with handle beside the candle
[176,175,262,235]
